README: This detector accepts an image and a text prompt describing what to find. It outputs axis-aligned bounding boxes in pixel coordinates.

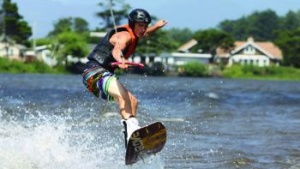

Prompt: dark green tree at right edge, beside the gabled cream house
[275,28,300,68]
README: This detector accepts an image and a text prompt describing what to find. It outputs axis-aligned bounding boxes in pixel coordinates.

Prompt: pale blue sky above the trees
[11,0,300,38]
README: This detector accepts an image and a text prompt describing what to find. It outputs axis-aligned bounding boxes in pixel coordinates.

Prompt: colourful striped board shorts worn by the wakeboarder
[82,66,117,100]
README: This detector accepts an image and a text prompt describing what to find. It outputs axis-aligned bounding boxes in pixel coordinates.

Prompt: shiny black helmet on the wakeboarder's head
[128,9,151,28]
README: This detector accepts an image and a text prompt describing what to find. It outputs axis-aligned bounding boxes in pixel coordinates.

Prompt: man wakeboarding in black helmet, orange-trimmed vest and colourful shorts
[83,9,167,145]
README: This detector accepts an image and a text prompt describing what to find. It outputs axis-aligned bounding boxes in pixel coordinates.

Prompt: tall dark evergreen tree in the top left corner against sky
[0,0,32,45]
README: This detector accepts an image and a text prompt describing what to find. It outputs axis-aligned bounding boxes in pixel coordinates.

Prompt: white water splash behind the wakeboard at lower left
[0,107,164,169]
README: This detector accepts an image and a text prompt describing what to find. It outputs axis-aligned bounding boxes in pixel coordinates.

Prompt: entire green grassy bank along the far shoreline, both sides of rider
[0,58,300,81]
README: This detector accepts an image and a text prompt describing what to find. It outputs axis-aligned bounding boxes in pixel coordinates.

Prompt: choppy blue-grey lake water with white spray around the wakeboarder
[0,74,300,169]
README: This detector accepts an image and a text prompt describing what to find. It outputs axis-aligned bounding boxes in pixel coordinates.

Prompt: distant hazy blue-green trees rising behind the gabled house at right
[218,9,300,41]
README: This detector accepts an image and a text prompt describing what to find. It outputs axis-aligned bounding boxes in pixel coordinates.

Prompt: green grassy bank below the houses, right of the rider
[178,62,300,81]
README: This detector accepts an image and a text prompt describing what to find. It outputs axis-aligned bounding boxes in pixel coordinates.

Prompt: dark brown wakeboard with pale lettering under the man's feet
[125,122,167,165]
